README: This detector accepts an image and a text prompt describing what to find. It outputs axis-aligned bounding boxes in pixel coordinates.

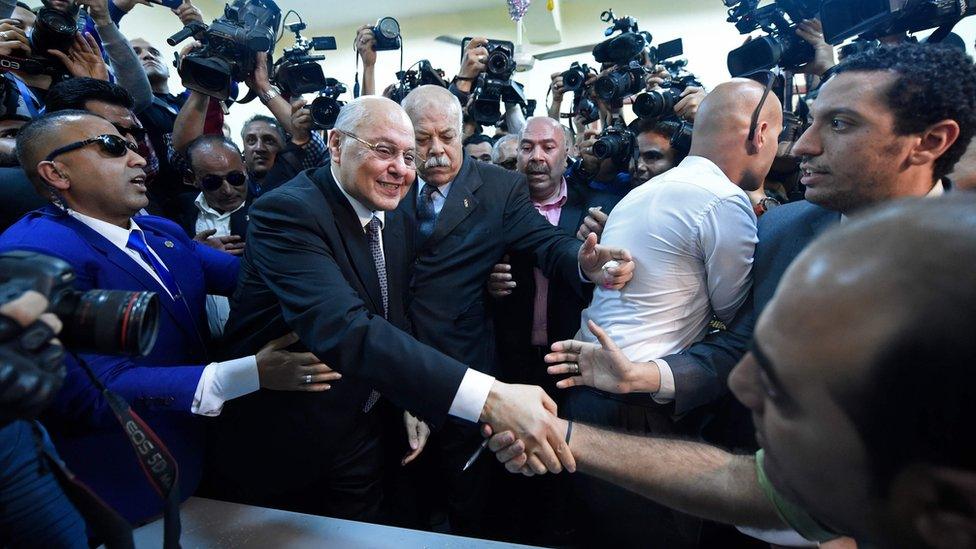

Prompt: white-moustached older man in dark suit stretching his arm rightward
[400,86,633,536]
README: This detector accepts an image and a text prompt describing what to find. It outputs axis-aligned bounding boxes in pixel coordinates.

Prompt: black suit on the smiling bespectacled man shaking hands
[209,167,466,519]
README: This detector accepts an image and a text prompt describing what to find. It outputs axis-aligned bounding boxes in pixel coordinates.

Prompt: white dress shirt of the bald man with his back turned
[577,156,757,403]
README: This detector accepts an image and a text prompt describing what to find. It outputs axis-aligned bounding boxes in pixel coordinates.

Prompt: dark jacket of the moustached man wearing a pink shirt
[490,186,620,364]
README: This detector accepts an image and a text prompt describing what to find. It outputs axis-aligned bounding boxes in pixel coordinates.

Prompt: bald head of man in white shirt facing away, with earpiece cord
[689,78,783,191]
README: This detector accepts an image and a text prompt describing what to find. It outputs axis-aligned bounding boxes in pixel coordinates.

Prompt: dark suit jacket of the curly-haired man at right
[664,201,840,414]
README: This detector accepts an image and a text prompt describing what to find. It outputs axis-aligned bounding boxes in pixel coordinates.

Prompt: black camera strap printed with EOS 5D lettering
[75,355,180,549]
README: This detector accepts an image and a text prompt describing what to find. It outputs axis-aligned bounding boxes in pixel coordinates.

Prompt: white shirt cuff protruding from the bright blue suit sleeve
[190,356,261,416]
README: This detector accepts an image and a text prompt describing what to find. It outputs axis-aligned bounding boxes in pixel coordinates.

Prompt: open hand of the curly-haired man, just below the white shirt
[545,320,660,394]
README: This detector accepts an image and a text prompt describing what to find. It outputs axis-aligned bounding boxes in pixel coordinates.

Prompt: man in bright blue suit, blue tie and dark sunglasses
[0,110,331,523]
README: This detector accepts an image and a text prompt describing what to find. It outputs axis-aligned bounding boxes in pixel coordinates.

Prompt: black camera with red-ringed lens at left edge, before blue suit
[0,251,159,424]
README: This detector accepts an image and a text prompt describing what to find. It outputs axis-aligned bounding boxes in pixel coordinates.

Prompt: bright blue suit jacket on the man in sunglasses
[0,206,238,522]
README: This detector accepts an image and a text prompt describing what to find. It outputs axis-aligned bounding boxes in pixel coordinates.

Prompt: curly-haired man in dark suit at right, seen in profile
[548,44,976,446]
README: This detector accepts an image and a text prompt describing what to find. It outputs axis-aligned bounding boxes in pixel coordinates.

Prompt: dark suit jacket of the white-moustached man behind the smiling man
[398,157,583,374]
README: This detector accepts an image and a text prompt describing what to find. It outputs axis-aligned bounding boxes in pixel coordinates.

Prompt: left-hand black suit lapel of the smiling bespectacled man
[315,168,389,314]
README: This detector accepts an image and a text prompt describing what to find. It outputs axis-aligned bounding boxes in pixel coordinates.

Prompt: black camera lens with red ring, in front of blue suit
[52,290,159,355]
